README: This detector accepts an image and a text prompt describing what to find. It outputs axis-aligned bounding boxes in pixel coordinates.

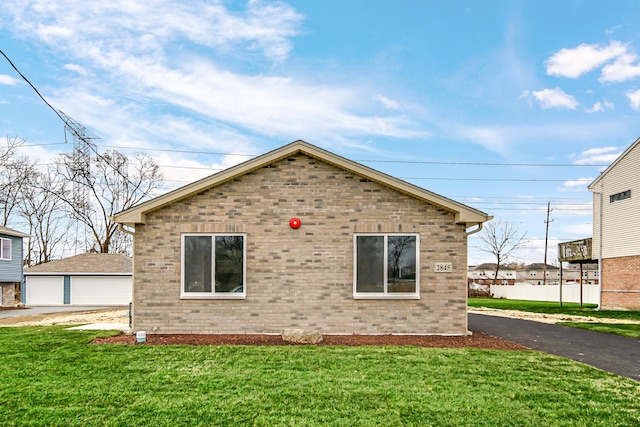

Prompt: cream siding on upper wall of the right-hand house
[593,144,640,258]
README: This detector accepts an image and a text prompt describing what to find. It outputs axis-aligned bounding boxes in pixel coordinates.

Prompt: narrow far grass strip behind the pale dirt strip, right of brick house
[468,298,640,321]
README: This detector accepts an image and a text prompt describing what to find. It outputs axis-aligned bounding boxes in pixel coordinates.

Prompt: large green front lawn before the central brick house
[0,326,640,426]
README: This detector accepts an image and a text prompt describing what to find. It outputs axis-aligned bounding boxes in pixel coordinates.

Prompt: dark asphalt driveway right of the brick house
[468,313,640,382]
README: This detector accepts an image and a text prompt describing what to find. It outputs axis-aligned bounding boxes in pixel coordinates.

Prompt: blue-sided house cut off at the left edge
[0,226,29,307]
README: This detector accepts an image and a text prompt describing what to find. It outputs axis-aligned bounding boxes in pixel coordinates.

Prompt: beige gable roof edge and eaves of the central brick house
[112,140,492,227]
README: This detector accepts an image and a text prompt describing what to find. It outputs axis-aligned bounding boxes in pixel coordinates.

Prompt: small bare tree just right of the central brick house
[479,220,527,285]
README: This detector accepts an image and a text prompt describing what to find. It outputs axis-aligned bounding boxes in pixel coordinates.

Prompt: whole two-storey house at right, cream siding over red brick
[589,138,640,310]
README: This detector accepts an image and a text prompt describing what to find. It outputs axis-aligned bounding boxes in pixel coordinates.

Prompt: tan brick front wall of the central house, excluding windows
[133,155,467,334]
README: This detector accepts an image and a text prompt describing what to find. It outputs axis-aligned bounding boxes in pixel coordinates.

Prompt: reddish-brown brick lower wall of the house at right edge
[602,256,640,310]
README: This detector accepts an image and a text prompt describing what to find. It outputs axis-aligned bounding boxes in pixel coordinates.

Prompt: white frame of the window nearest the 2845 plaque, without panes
[353,233,421,300]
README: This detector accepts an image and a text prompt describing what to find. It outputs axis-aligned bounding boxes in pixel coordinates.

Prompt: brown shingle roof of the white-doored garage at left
[24,253,133,275]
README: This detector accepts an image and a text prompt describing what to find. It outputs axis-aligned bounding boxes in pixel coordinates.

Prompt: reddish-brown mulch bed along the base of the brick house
[91,332,527,350]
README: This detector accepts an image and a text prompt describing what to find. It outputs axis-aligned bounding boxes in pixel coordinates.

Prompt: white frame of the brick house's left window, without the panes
[180,233,247,300]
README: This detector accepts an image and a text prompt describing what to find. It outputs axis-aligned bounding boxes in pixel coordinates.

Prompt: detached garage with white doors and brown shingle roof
[23,253,132,306]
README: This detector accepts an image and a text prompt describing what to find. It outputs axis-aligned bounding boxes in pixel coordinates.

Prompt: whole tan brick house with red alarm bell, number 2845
[114,141,490,335]
